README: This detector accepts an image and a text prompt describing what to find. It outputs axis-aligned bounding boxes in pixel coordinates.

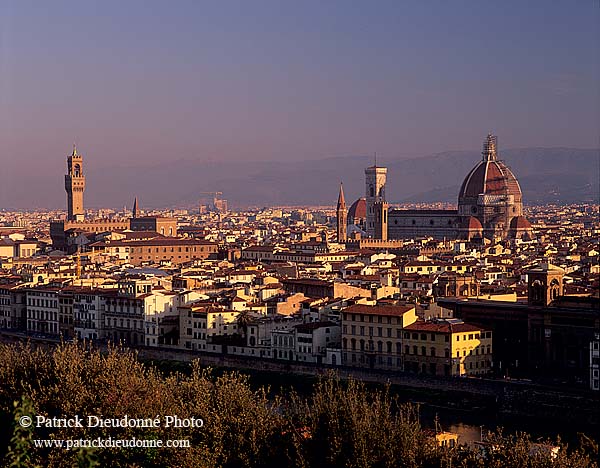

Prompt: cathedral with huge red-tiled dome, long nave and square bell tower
[348,134,531,240]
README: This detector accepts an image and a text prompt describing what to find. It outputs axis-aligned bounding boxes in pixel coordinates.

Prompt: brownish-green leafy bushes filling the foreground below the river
[0,344,598,468]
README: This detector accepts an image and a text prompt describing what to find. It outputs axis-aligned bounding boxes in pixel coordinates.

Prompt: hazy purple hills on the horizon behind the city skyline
[0,148,600,208]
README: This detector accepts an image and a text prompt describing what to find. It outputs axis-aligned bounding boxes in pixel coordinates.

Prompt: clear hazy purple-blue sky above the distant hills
[0,0,600,179]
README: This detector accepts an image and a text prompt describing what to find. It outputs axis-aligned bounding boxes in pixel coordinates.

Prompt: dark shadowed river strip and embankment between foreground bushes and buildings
[0,334,600,439]
